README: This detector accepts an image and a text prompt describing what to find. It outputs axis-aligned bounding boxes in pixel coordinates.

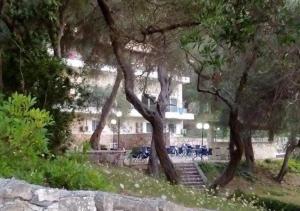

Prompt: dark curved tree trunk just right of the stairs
[212,111,244,189]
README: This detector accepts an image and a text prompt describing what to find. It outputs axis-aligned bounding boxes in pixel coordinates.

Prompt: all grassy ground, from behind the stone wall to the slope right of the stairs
[0,150,300,211]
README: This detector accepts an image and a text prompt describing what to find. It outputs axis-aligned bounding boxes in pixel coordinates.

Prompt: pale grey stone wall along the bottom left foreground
[0,179,209,211]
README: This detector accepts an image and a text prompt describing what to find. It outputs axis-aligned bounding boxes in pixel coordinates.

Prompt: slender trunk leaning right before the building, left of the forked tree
[90,70,123,150]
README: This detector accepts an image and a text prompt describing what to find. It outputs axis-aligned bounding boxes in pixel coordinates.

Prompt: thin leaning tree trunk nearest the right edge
[275,137,300,182]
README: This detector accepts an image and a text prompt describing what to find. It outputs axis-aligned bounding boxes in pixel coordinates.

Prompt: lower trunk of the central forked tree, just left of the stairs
[151,115,178,184]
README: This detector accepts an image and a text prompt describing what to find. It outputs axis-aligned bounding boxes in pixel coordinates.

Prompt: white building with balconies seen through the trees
[66,51,194,148]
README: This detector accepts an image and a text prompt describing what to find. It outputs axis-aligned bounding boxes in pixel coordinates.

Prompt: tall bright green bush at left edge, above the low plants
[0,93,52,158]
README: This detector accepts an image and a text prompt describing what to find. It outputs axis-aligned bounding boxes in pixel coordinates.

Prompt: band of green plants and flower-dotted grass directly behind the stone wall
[0,152,258,211]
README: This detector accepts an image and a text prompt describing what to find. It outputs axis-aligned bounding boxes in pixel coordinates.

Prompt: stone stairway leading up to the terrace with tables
[175,162,205,188]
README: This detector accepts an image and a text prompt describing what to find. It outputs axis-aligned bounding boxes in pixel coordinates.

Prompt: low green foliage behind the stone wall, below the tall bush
[0,152,114,191]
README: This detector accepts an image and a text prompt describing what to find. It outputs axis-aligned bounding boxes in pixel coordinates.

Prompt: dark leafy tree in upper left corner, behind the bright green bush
[0,0,85,152]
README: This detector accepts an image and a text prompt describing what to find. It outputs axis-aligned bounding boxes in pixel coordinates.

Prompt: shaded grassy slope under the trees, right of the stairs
[200,160,300,205]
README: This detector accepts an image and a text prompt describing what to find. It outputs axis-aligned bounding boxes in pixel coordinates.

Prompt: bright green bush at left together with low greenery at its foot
[0,94,112,190]
